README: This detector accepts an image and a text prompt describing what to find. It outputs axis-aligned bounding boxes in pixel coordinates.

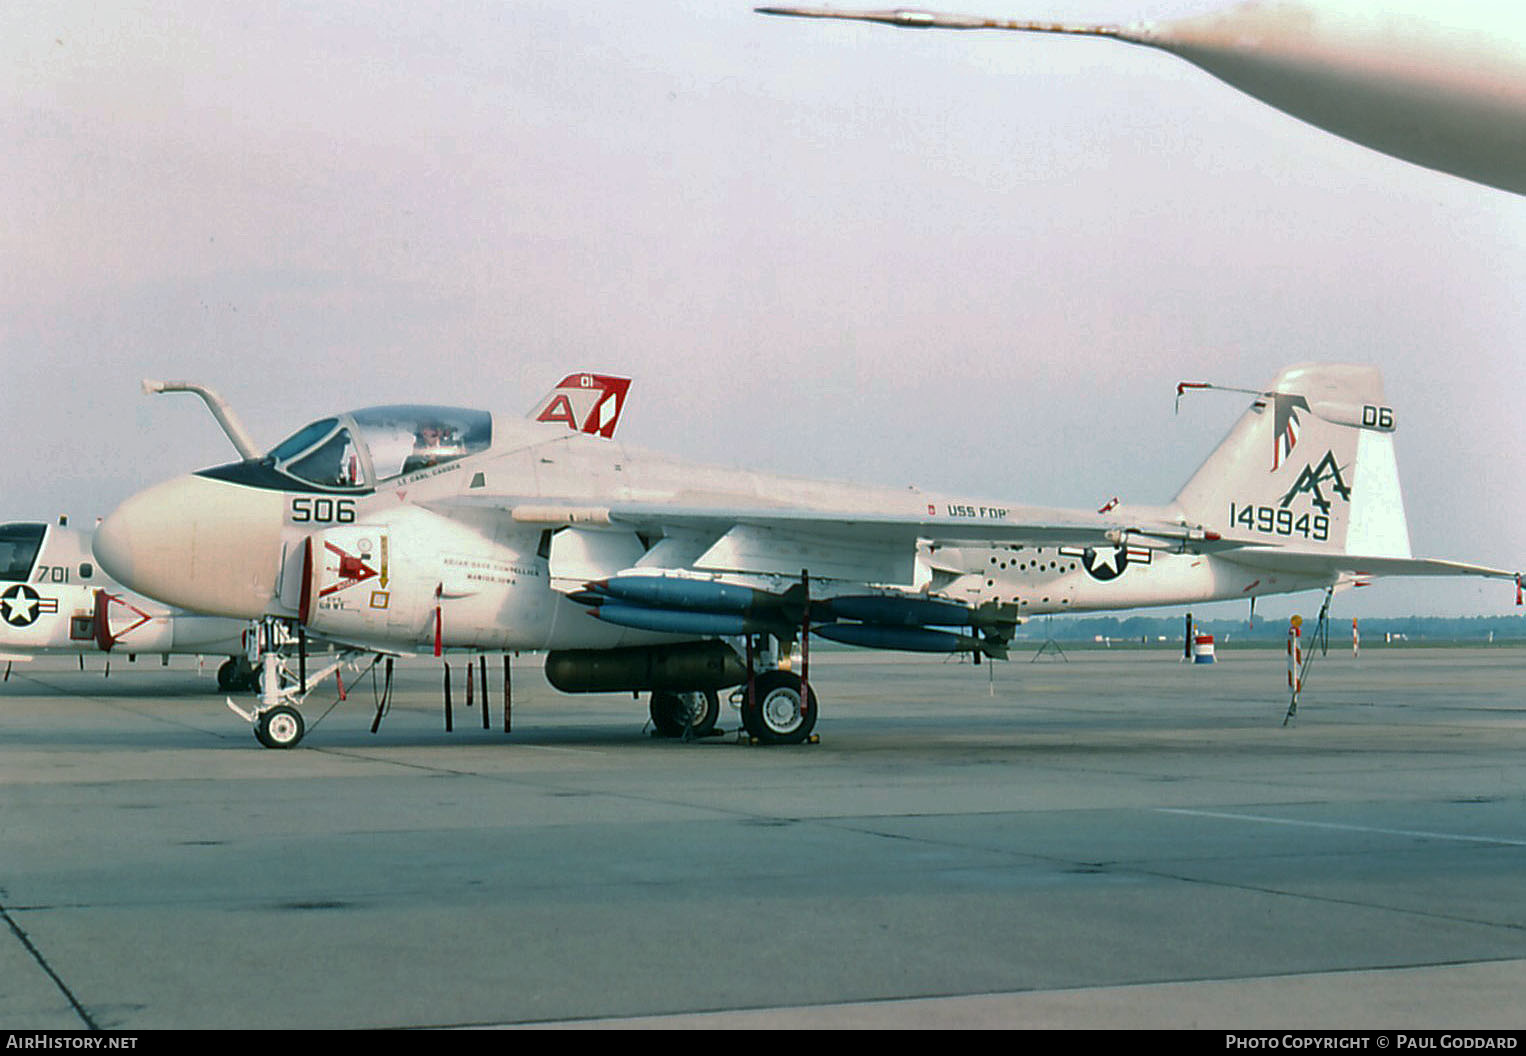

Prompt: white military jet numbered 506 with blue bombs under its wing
[95,363,1514,746]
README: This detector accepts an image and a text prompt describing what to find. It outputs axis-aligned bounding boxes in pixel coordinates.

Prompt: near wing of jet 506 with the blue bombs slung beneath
[435,494,1212,656]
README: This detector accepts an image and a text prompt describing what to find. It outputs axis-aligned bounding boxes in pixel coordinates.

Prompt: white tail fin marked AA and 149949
[1175,363,1410,557]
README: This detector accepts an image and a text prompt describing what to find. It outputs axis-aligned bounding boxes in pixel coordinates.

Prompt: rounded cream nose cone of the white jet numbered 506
[95,476,285,620]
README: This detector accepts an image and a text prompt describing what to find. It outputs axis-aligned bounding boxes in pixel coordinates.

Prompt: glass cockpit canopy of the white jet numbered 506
[266,403,493,491]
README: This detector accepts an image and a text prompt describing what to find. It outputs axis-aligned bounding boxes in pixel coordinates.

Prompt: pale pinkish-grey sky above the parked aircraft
[0,0,1526,615]
